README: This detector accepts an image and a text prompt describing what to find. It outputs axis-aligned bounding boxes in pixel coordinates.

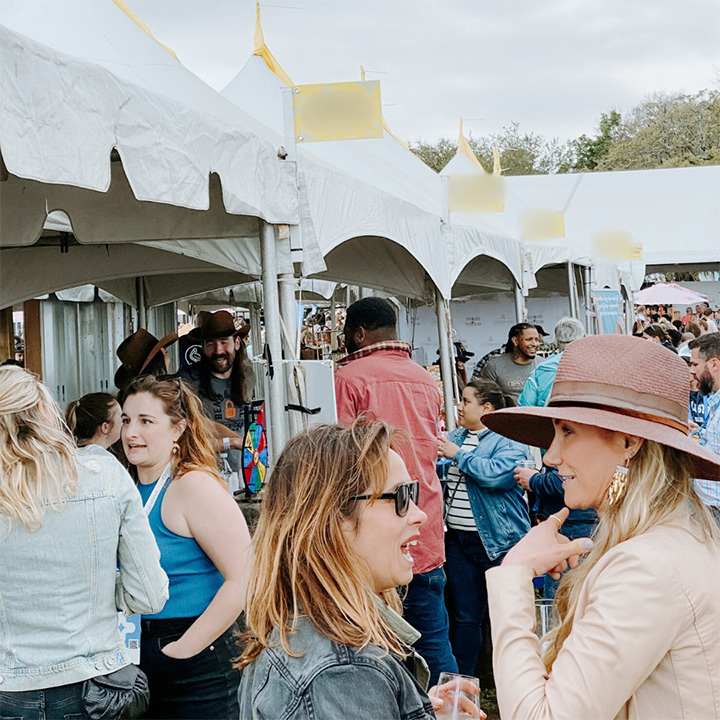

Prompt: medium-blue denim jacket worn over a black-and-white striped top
[444,428,530,560]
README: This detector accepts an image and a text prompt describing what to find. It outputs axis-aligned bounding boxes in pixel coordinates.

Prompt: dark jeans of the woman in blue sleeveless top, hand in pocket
[140,618,240,720]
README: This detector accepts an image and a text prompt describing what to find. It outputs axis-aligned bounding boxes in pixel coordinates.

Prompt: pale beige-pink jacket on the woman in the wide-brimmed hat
[486,511,720,720]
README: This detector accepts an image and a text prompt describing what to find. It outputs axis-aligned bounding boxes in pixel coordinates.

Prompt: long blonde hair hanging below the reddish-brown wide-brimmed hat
[543,440,720,672]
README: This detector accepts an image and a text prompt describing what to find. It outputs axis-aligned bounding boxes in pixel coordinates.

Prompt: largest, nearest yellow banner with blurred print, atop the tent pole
[293,80,383,143]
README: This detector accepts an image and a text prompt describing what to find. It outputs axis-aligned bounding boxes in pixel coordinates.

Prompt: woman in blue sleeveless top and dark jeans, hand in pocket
[122,374,252,720]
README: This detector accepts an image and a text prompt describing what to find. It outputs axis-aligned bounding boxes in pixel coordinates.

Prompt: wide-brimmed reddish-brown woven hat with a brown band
[483,335,720,480]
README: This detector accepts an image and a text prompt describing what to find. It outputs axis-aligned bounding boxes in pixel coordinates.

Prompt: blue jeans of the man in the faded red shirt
[403,567,457,687]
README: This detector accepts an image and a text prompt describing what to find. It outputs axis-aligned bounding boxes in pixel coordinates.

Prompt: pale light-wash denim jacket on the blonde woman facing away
[0,454,168,692]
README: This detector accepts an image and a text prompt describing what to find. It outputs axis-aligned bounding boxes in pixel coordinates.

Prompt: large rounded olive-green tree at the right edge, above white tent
[596,90,720,170]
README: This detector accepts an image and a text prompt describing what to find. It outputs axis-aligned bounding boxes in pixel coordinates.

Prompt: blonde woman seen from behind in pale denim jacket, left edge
[0,366,168,720]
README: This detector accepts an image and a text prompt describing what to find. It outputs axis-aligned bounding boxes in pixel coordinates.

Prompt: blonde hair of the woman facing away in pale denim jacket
[0,365,78,530]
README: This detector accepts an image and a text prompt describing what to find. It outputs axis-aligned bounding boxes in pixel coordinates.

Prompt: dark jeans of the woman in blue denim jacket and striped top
[445,528,502,675]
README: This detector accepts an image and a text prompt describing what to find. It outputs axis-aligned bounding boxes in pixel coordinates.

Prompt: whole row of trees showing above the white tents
[410,90,720,175]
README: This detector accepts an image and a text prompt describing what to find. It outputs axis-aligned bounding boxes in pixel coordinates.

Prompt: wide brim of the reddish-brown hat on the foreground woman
[483,405,720,481]
